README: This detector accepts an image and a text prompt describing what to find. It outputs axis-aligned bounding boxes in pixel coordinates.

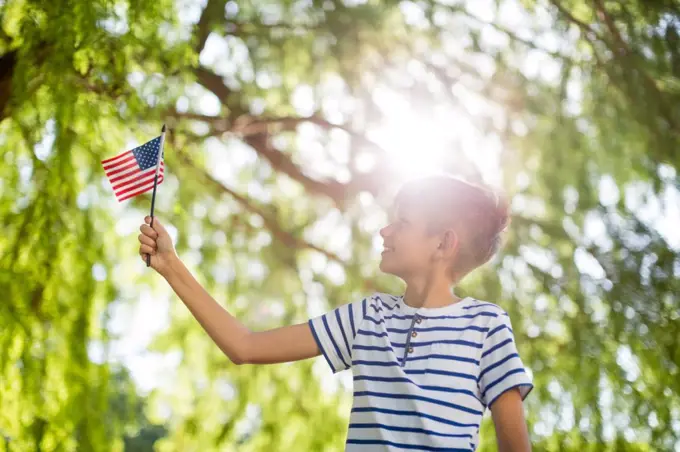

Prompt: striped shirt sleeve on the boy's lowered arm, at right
[478,313,534,407]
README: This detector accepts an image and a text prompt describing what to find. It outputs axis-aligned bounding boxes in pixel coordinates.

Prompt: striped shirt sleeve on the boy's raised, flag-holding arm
[309,298,368,373]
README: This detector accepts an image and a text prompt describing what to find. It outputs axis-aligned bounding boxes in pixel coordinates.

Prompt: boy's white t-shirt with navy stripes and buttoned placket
[309,293,533,451]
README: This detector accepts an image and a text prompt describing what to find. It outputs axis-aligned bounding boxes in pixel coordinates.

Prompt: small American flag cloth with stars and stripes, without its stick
[102,137,164,202]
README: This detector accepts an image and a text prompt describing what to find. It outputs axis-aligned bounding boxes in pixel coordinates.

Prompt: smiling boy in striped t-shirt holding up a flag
[139,176,533,452]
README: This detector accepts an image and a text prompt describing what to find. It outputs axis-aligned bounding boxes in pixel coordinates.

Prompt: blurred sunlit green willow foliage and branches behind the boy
[0,0,680,452]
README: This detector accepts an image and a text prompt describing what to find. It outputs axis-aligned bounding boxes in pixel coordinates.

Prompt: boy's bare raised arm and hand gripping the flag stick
[139,217,321,364]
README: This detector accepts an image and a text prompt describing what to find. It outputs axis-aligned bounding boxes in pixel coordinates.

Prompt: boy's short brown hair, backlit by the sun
[396,175,510,278]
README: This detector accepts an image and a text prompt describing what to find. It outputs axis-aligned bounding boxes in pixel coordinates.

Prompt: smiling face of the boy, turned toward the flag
[380,207,440,282]
